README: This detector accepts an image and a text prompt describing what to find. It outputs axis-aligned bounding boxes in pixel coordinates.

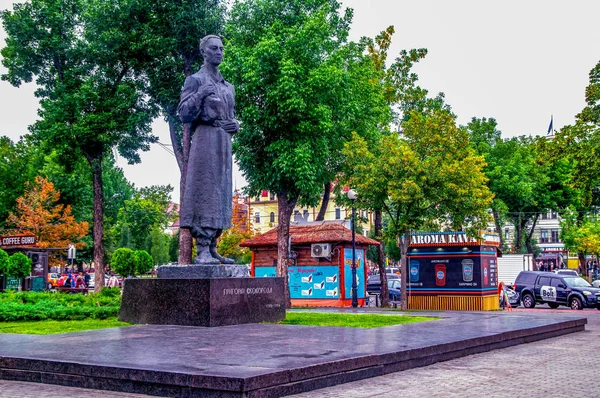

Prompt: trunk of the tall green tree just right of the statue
[277,191,297,308]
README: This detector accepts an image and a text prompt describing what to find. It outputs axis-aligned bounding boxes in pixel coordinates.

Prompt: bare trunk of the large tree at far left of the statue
[86,154,104,293]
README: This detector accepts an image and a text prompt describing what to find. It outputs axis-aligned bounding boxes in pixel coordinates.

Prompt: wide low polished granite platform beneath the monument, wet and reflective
[0,310,586,398]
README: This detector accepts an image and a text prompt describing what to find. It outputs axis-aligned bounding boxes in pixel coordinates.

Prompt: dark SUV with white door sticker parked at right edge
[514,271,600,310]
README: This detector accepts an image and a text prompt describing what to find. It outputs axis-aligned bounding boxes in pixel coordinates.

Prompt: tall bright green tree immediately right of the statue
[222,0,384,304]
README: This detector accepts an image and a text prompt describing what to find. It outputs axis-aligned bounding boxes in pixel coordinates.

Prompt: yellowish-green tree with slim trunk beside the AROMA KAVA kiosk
[344,109,492,308]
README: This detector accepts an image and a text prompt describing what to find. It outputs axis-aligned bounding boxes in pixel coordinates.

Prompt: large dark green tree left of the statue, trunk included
[0,0,156,290]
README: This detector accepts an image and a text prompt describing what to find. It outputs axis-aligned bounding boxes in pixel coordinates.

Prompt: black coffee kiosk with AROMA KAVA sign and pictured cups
[406,232,500,311]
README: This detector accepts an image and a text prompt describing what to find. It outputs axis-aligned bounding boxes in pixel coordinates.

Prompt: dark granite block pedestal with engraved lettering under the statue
[119,265,285,327]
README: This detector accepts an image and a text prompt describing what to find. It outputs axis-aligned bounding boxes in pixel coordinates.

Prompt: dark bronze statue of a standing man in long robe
[178,35,239,264]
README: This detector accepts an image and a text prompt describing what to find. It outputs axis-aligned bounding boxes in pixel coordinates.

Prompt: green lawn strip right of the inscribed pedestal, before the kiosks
[278,312,438,328]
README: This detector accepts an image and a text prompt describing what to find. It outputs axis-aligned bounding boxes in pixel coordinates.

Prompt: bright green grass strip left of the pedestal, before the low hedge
[0,318,131,334]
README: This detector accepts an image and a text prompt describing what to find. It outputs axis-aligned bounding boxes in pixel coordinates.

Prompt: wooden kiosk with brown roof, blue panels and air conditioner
[241,222,379,307]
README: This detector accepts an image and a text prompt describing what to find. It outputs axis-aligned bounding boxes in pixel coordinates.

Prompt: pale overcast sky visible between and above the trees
[0,0,600,205]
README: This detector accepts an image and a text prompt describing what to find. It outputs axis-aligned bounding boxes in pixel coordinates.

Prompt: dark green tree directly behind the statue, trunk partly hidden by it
[123,0,226,264]
